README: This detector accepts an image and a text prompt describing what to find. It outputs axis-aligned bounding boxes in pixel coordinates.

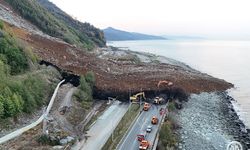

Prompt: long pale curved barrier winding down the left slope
[0,80,65,144]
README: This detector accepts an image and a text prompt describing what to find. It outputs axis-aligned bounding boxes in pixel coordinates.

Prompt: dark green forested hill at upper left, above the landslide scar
[6,0,106,50]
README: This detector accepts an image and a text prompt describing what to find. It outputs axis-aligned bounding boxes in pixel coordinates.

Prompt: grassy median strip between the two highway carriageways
[102,104,140,150]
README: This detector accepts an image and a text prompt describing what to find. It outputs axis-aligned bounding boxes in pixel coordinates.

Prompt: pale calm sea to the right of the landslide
[108,39,250,128]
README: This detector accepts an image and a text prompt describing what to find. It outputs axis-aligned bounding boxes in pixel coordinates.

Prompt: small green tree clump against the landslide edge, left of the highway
[74,72,95,109]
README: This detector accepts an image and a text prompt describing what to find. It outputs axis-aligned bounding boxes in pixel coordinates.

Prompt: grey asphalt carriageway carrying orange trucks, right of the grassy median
[117,104,166,150]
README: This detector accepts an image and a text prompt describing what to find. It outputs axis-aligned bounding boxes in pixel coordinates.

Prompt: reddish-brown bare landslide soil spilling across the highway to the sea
[28,31,232,93]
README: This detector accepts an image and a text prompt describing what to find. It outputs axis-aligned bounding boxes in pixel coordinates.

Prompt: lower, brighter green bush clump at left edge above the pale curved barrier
[0,66,49,119]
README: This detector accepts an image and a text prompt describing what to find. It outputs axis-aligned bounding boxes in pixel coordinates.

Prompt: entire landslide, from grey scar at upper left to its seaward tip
[0,0,233,101]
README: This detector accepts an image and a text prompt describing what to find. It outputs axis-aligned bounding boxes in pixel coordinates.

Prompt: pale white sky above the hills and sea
[50,0,250,40]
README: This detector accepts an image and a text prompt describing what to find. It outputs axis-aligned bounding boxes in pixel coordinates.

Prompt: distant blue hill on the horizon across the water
[103,27,165,41]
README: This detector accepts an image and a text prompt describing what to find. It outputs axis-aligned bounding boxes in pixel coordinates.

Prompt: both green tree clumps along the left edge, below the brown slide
[0,22,50,120]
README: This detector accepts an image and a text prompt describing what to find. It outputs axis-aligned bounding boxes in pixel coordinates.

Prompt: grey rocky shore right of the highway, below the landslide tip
[174,92,250,150]
